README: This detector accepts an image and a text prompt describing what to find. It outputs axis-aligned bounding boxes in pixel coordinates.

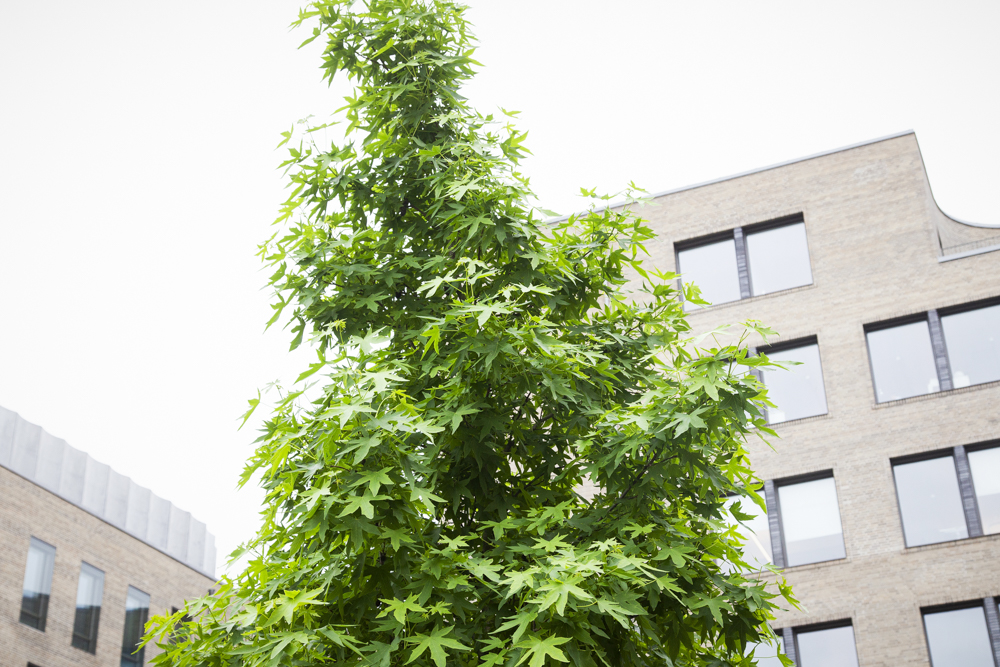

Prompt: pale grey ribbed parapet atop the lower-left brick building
[0,407,215,579]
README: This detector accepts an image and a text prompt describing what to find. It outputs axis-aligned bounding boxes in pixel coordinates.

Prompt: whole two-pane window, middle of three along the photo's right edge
[892,443,1000,547]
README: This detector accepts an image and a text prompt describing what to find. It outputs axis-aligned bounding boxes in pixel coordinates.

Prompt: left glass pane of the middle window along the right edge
[892,456,969,547]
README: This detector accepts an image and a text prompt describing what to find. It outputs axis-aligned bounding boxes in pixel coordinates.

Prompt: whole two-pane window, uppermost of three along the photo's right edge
[865,303,1000,403]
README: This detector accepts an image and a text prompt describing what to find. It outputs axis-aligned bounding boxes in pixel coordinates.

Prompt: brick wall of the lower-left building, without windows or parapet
[0,466,214,667]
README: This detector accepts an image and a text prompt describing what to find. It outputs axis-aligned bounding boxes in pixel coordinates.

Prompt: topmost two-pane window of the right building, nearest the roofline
[676,214,812,310]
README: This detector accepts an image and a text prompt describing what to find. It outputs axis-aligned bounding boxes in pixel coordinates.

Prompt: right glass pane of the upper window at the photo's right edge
[941,306,1000,388]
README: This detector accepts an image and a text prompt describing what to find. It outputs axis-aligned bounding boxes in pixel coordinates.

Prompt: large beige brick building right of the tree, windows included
[620,132,1000,667]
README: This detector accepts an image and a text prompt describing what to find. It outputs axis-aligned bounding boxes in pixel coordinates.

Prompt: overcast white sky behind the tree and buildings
[0,0,1000,570]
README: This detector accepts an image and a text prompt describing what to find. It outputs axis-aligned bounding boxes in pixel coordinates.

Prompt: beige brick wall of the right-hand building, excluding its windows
[628,133,1000,667]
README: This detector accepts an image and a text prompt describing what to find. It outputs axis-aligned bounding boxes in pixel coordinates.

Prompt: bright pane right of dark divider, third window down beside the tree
[778,477,847,566]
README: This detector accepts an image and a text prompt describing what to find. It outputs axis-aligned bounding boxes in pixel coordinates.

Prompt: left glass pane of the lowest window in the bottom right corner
[924,607,994,667]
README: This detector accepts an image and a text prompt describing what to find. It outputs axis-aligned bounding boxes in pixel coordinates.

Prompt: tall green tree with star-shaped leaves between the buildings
[151,0,790,667]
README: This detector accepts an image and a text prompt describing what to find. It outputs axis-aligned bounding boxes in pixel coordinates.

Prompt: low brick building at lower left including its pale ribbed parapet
[0,408,215,667]
